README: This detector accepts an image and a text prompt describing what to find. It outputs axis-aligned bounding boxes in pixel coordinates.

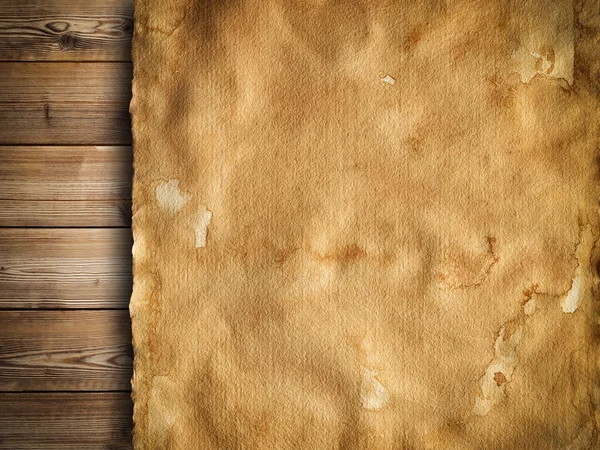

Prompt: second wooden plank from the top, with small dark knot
[0,62,133,145]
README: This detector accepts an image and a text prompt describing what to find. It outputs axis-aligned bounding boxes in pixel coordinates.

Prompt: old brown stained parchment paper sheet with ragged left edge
[131,0,600,450]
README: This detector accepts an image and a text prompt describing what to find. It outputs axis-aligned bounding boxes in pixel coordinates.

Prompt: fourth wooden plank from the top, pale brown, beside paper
[0,228,132,309]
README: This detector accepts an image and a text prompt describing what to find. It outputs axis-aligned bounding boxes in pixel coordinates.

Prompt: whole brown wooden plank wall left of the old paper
[0,0,133,450]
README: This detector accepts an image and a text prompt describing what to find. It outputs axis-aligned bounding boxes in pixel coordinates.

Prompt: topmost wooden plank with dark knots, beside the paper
[0,0,133,61]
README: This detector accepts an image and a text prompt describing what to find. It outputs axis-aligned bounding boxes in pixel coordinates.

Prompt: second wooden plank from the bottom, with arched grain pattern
[0,311,132,392]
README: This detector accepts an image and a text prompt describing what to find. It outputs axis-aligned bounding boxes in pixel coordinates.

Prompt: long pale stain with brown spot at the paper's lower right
[473,320,531,416]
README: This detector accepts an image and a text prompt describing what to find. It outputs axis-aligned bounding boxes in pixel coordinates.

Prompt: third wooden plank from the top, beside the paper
[0,146,132,227]
